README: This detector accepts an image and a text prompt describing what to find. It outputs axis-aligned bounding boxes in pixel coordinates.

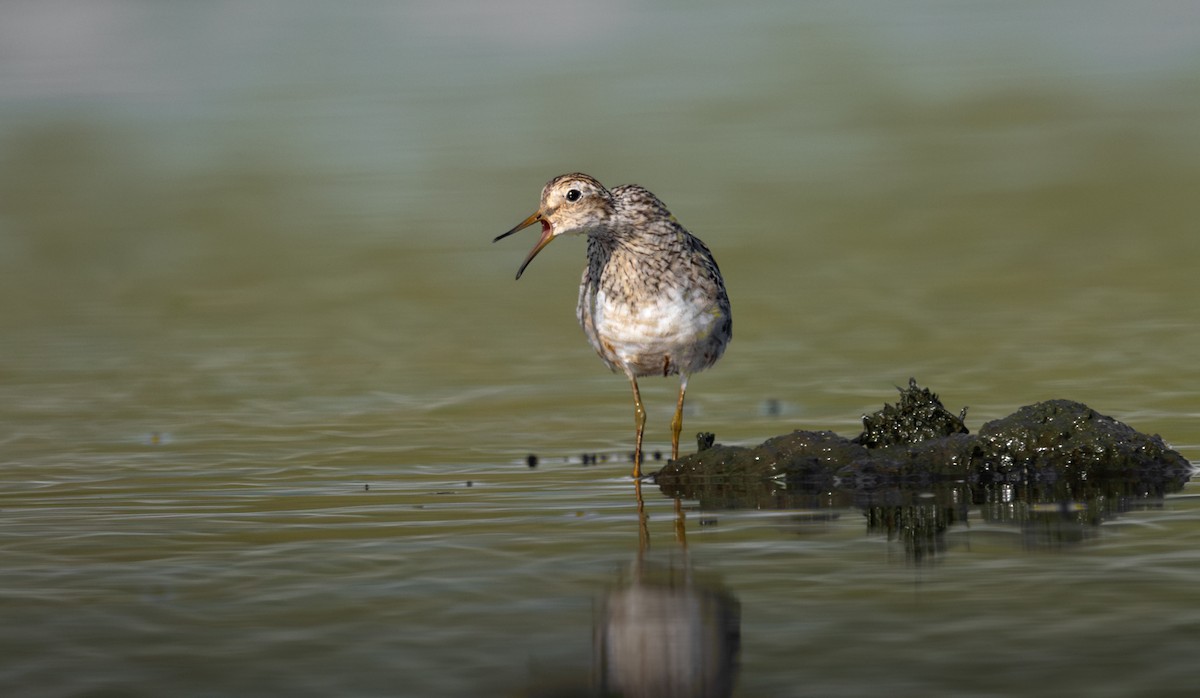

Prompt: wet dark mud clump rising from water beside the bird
[655,380,1192,498]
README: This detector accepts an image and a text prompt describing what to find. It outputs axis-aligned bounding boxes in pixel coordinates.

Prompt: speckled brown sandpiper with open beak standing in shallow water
[493,173,733,480]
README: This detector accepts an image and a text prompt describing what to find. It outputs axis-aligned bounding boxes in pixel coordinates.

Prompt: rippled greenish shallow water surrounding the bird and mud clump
[0,1,1200,696]
